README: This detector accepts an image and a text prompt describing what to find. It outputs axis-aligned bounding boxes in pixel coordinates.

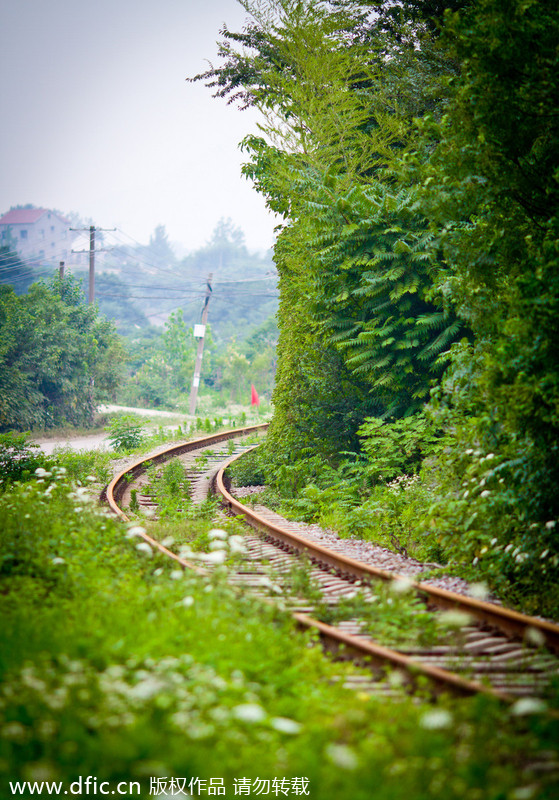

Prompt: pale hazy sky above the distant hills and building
[0,0,276,250]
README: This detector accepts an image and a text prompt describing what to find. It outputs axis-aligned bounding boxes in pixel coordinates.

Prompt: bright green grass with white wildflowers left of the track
[0,472,559,800]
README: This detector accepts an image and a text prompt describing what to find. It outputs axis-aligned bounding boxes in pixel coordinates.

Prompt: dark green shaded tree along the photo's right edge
[420,0,559,519]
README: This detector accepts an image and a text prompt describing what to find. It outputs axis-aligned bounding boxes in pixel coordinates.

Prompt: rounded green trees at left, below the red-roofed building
[0,278,122,430]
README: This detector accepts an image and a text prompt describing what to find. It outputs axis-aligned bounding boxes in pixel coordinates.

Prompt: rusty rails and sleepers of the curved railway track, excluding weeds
[106,424,559,702]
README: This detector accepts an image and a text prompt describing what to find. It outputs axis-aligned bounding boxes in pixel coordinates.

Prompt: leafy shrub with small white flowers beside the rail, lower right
[417,440,559,615]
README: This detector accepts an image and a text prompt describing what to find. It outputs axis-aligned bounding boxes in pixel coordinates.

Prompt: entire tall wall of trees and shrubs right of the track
[203,0,559,616]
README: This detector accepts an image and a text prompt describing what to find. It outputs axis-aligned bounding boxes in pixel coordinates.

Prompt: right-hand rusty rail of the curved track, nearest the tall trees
[215,451,559,652]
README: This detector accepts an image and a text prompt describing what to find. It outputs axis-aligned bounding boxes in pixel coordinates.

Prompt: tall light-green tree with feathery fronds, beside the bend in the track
[199,0,463,452]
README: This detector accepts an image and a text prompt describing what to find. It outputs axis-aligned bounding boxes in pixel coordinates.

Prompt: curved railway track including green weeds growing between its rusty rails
[106,432,559,701]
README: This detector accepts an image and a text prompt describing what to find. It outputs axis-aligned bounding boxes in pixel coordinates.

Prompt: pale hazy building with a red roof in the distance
[0,208,76,264]
